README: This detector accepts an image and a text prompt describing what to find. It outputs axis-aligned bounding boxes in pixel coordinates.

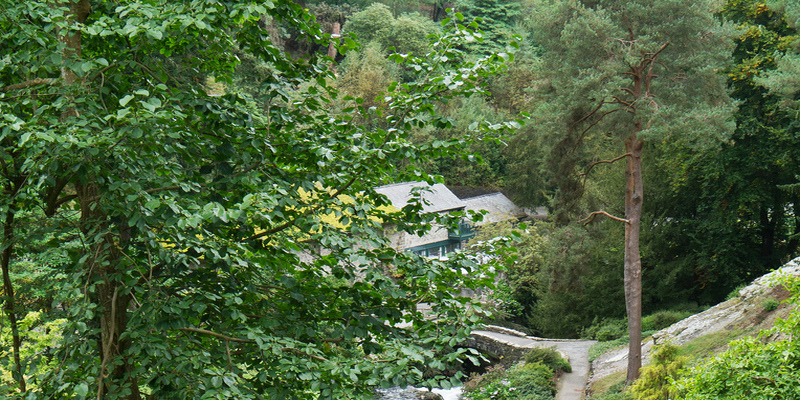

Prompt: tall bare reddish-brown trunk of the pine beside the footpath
[624,133,644,384]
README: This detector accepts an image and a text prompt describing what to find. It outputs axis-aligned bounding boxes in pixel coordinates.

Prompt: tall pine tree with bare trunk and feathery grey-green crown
[520,0,731,382]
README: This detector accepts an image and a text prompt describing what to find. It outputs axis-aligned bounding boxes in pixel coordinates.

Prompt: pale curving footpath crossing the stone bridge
[473,330,597,400]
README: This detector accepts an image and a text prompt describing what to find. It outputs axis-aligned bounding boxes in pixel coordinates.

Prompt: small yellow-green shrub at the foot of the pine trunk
[628,343,687,400]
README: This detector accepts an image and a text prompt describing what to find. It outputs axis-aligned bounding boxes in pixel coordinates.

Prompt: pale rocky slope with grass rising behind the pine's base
[587,258,800,392]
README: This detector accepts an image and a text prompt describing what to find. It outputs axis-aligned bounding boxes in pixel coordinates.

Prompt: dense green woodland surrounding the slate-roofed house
[0,0,800,399]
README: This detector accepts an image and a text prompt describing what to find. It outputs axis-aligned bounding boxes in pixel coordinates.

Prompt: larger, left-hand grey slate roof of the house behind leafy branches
[375,182,466,212]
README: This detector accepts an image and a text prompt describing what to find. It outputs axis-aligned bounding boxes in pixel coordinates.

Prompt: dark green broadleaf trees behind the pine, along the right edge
[649,0,800,304]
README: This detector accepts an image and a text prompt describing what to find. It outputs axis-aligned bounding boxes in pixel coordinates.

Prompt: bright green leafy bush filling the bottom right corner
[672,278,800,400]
